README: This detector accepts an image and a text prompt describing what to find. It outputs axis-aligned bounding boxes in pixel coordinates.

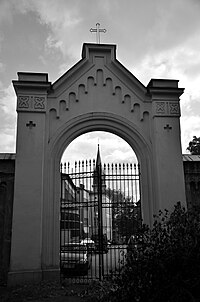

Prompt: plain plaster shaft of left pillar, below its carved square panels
[10,113,45,271]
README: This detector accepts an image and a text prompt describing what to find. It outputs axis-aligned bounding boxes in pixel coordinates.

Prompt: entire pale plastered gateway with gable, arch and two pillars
[8,44,185,284]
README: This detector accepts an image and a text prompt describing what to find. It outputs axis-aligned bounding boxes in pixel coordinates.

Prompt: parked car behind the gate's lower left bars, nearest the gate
[60,243,91,275]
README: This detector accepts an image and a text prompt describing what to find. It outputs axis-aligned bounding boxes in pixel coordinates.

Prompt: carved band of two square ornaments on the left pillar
[17,95,46,112]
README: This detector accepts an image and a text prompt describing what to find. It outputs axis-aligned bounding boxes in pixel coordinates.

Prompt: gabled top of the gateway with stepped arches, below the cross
[48,44,149,121]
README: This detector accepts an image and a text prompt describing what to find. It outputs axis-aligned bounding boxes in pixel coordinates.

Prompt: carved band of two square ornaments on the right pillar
[153,101,180,117]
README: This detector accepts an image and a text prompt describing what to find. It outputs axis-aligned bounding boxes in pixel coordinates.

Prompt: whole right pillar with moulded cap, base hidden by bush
[147,79,186,211]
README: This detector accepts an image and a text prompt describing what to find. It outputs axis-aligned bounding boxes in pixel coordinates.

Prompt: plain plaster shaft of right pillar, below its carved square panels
[153,117,185,211]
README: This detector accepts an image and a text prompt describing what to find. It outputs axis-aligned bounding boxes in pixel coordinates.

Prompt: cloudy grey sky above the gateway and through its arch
[0,0,200,161]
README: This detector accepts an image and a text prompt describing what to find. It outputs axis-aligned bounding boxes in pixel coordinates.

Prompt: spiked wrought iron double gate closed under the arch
[60,156,141,283]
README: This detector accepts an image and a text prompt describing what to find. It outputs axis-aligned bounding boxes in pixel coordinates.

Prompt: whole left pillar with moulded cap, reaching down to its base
[8,73,51,284]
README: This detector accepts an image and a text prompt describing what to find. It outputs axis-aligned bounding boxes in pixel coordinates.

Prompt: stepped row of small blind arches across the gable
[54,71,149,121]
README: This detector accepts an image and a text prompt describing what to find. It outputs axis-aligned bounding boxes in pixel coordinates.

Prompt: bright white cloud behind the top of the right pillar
[135,41,200,153]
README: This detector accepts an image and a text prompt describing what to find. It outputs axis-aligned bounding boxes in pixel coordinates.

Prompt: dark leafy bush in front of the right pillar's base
[102,203,200,302]
